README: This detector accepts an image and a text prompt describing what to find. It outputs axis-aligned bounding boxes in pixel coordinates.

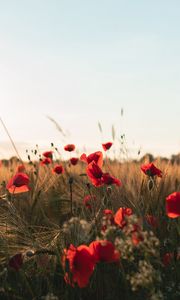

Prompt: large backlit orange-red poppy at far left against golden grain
[6,173,30,194]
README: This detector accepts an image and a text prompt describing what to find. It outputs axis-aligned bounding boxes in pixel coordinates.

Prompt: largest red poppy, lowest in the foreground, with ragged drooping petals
[65,245,95,288]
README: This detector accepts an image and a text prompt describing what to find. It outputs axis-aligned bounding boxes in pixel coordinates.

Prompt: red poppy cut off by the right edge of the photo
[166,192,180,218]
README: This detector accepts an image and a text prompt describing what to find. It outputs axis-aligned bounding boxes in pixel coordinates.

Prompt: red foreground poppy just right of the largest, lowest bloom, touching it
[89,240,120,263]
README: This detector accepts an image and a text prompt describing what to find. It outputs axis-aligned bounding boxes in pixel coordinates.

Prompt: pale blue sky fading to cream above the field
[0,0,180,158]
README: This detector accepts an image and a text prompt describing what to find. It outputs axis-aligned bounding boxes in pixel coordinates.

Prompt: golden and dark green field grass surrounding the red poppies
[0,150,180,300]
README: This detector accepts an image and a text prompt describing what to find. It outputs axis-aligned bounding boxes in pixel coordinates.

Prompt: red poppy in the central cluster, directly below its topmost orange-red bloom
[86,161,103,186]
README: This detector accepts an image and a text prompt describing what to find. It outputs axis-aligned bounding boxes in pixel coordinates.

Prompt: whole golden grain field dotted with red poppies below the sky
[0,145,180,300]
